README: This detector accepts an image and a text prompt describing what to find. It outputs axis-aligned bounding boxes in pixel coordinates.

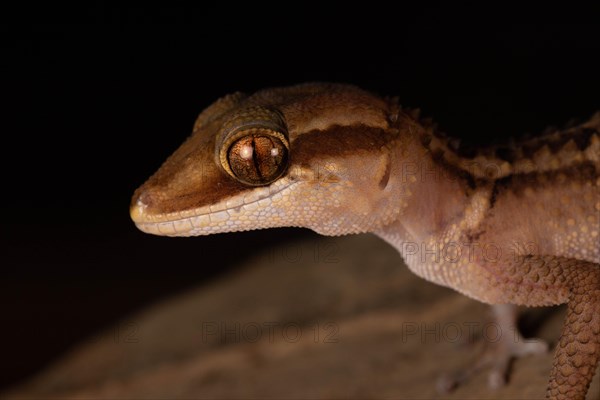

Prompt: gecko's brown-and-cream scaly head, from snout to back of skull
[130,84,406,236]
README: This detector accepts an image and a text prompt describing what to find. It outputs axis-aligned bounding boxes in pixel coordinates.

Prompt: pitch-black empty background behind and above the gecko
[0,2,600,387]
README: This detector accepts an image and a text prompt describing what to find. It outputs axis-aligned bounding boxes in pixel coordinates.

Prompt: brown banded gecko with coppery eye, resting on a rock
[130,83,600,399]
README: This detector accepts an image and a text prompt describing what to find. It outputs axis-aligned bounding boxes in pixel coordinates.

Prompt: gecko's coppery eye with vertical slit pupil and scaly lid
[215,107,289,186]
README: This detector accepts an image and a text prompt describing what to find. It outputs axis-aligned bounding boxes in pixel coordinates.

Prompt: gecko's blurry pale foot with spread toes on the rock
[436,304,549,393]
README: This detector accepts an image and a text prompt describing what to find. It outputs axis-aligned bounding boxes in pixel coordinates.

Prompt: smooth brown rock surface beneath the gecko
[0,235,600,399]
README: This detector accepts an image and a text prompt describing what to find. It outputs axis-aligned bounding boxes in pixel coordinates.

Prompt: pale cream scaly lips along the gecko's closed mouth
[130,181,298,236]
